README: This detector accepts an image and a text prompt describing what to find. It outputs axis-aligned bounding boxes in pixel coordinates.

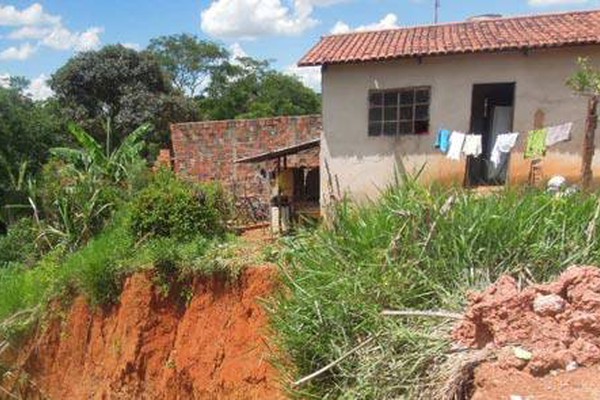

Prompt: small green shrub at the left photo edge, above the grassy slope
[0,218,39,267]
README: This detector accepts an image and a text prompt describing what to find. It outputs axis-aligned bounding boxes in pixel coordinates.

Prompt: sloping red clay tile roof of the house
[298,10,600,66]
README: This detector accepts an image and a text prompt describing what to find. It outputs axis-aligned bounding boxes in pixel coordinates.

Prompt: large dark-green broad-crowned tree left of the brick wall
[50,45,196,147]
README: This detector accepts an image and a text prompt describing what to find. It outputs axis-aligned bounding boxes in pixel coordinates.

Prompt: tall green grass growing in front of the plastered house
[273,182,600,399]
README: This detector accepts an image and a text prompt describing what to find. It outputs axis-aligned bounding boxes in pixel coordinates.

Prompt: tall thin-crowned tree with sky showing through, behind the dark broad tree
[148,34,229,97]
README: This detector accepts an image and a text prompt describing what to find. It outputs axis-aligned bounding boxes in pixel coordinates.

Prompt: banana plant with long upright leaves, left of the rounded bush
[38,124,151,250]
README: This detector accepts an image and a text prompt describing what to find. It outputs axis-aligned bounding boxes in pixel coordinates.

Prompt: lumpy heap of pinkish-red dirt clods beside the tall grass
[453,267,600,376]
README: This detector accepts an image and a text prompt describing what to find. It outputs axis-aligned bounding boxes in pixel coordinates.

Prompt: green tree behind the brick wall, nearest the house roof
[201,57,321,119]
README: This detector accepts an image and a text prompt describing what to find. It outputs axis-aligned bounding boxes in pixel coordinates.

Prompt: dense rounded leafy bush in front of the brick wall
[130,170,225,239]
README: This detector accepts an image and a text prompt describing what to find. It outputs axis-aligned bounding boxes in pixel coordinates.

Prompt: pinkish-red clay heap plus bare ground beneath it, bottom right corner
[453,267,600,400]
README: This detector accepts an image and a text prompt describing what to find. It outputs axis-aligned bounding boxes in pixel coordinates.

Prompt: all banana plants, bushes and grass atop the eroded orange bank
[0,119,238,346]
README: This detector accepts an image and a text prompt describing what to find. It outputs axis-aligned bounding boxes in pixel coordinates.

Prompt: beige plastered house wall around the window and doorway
[321,46,600,200]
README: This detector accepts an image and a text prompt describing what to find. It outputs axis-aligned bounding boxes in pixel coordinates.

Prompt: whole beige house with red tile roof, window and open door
[299,10,600,198]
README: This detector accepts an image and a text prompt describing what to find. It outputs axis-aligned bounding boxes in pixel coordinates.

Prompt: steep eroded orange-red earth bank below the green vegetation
[7,268,283,399]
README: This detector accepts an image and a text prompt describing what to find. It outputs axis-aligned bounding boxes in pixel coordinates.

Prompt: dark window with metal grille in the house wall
[369,87,431,136]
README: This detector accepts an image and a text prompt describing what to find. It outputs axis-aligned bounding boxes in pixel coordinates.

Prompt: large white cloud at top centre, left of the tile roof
[201,0,347,40]
